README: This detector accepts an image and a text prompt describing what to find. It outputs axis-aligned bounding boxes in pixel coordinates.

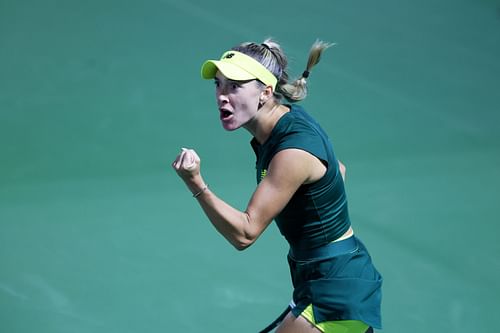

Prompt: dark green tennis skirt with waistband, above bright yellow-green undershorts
[288,236,382,329]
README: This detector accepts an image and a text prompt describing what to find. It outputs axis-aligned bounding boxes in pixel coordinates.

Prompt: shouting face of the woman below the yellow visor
[214,72,262,131]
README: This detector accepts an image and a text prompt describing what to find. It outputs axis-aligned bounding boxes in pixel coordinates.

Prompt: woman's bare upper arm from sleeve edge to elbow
[241,149,326,239]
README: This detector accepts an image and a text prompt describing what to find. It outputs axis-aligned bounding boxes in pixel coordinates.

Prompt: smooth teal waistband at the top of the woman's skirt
[288,235,358,260]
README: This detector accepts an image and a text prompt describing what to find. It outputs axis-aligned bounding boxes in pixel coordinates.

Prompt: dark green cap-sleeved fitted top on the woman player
[251,105,350,250]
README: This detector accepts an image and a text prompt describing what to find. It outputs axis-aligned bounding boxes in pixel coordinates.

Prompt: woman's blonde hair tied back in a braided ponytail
[232,38,334,103]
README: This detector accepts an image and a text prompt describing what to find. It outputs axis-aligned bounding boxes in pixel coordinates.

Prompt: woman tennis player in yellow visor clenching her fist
[172,39,382,333]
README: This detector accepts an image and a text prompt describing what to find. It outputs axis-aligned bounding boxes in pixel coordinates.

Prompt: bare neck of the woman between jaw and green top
[245,102,288,144]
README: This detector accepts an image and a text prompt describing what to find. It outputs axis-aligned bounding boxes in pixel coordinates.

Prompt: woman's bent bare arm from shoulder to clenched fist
[173,149,326,250]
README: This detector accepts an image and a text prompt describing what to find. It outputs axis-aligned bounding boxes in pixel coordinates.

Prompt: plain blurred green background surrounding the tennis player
[0,0,500,333]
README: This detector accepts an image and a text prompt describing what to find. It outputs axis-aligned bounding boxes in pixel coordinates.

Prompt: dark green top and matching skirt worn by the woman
[251,104,382,329]
